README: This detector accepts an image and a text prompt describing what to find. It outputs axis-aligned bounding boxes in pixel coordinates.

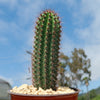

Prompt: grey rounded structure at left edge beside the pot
[0,79,11,100]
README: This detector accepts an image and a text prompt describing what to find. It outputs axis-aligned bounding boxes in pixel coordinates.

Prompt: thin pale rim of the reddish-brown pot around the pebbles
[8,87,80,97]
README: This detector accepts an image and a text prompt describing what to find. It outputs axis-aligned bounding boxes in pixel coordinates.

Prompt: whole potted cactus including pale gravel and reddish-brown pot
[10,10,79,100]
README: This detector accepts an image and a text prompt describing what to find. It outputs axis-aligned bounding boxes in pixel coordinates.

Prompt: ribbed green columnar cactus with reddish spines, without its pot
[32,10,61,90]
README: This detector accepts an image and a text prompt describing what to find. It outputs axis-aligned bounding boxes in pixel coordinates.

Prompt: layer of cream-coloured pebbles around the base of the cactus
[10,84,75,95]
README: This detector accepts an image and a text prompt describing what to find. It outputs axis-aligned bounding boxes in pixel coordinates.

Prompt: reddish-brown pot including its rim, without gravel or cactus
[9,88,79,100]
